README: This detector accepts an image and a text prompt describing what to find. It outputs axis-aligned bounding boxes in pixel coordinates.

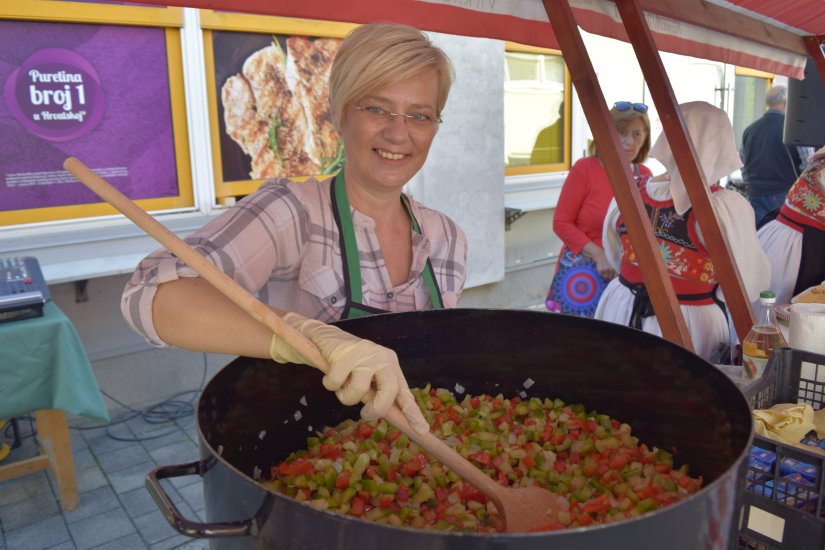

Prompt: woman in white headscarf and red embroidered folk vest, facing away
[595,101,770,362]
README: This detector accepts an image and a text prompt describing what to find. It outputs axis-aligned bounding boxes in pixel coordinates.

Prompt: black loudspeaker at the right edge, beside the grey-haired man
[784,58,825,148]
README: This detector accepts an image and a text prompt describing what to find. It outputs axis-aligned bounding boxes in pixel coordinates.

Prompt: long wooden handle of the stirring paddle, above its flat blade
[63,157,504,506]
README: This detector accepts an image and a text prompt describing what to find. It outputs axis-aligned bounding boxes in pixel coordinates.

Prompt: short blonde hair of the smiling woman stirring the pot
[329,23,455,129]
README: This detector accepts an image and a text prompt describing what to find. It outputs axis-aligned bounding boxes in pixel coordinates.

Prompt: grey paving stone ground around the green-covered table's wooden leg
[0,414,209,550]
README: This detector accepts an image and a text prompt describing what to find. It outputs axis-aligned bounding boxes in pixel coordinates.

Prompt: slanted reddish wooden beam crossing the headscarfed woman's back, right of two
[616,0,753,341]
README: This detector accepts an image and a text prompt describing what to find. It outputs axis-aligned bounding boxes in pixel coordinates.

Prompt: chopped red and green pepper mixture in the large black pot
[263,385,702,533]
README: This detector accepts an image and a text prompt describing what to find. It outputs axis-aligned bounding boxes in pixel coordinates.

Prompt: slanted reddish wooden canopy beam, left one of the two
[543,0,693,351]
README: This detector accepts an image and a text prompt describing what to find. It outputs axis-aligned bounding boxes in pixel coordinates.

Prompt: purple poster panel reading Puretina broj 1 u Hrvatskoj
[0,21,179,211]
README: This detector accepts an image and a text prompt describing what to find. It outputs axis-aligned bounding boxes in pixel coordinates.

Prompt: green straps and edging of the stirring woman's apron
[330,175,444,319]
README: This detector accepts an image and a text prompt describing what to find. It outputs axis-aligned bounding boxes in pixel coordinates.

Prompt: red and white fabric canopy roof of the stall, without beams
[138,0,825,79]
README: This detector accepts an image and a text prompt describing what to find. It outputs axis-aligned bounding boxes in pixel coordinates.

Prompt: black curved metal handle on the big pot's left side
[146,461,255,538]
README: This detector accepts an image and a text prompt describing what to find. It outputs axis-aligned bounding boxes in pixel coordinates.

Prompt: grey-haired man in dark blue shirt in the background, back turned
[740,86,799,226]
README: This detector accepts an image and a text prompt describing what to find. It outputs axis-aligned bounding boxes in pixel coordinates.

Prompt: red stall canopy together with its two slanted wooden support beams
[124,0,825,349]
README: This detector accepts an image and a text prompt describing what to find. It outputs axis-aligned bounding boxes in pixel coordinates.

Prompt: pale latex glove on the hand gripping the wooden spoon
[269,312,430,433]
